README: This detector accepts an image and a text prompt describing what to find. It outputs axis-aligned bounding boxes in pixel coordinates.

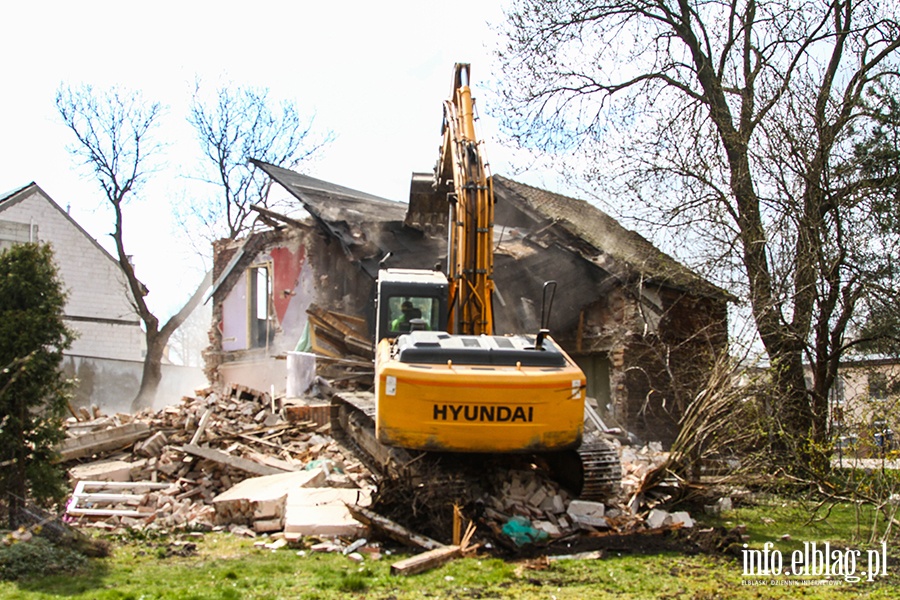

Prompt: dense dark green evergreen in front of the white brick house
[0,243,74,528]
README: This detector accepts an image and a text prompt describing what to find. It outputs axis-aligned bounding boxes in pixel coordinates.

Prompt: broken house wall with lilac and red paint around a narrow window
[204,226,374,394]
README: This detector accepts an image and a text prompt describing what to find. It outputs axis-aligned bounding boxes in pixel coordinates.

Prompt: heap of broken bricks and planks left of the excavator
[60,386,371,532]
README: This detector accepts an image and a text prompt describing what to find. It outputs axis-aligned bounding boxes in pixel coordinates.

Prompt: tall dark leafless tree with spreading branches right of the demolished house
[500,0,900,474]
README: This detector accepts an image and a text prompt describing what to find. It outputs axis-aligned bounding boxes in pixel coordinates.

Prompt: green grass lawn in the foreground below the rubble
[0,500,900,600]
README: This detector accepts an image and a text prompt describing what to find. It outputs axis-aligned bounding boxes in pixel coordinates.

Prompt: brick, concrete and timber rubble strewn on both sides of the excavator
[59,382,716,552]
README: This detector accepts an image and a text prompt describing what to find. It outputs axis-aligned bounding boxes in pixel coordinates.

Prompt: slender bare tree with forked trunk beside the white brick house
[56,85,211,410]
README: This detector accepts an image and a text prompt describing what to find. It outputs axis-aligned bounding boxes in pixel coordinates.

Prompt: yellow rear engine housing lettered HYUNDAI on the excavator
[375,331,585,453]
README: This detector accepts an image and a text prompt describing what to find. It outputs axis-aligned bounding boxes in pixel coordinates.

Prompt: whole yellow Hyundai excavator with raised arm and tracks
[333,64,621,499]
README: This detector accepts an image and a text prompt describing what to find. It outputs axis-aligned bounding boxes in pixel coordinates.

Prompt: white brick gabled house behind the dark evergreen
[0,183,205,412]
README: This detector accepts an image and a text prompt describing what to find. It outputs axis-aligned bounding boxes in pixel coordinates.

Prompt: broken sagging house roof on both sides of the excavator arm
[252,160,730,310]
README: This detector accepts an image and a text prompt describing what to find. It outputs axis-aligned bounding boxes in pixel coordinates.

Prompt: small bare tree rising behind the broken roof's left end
[188,82,333,241]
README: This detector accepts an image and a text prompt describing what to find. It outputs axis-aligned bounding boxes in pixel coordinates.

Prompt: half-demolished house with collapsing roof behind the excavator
[206,163,730,446]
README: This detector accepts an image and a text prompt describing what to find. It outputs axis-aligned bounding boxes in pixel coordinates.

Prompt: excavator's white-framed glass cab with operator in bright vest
[375,269,449,342]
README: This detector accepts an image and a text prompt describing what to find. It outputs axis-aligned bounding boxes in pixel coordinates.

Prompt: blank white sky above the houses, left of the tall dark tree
[0,0,564,315]
